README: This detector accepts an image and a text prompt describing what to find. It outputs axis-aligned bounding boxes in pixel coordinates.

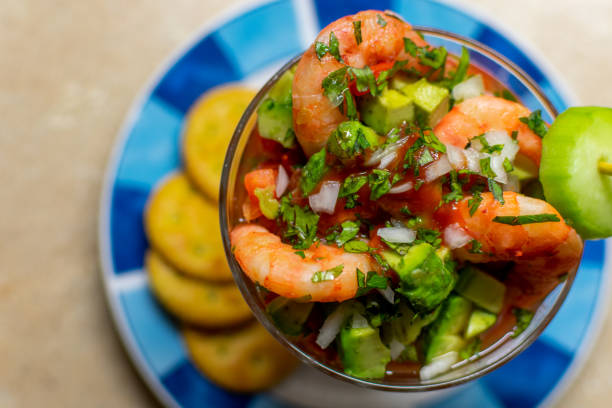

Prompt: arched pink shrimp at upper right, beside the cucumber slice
[434,95,542,169]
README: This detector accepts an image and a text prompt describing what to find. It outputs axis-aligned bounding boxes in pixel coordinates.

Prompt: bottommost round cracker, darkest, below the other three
[183,322,298,392]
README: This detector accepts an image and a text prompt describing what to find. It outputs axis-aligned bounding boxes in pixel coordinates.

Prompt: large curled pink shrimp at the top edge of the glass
[292,10,427,156]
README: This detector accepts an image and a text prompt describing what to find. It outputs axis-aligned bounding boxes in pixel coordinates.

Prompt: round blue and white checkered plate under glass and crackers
[99,0,612,408]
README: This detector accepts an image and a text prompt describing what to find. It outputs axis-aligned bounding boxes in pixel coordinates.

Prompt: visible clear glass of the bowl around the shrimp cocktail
[219,27,576,392]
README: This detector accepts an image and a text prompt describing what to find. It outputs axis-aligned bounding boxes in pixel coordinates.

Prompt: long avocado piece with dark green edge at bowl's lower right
[425,295,472,364]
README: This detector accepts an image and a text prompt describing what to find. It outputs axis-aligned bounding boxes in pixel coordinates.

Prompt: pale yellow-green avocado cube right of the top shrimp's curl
[401,78,450,128]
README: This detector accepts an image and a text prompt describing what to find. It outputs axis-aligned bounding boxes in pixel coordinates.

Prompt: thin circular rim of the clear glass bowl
[219,25,576,392]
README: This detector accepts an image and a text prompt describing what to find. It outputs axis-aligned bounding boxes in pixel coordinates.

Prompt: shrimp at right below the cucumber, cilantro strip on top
[438,191,583,308]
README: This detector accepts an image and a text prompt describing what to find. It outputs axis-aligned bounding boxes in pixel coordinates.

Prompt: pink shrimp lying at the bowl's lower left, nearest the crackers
[230,224,378,302]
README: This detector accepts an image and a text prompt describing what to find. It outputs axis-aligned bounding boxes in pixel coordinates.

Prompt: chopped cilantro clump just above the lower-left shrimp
[280,195,319,249]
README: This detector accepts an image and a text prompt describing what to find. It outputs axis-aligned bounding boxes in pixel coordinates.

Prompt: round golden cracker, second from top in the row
[145,173,232,282]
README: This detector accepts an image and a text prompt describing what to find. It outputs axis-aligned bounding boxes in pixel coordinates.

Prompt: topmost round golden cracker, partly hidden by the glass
[183,85,255,200]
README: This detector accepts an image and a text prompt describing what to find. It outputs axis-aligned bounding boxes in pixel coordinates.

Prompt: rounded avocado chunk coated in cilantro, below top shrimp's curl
[327,120,380,159]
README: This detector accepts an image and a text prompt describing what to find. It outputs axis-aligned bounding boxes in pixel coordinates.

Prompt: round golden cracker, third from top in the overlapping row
[146,251,253,328]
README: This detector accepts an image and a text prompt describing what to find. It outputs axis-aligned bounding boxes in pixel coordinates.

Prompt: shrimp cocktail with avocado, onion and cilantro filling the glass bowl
[229,10,612,381]
